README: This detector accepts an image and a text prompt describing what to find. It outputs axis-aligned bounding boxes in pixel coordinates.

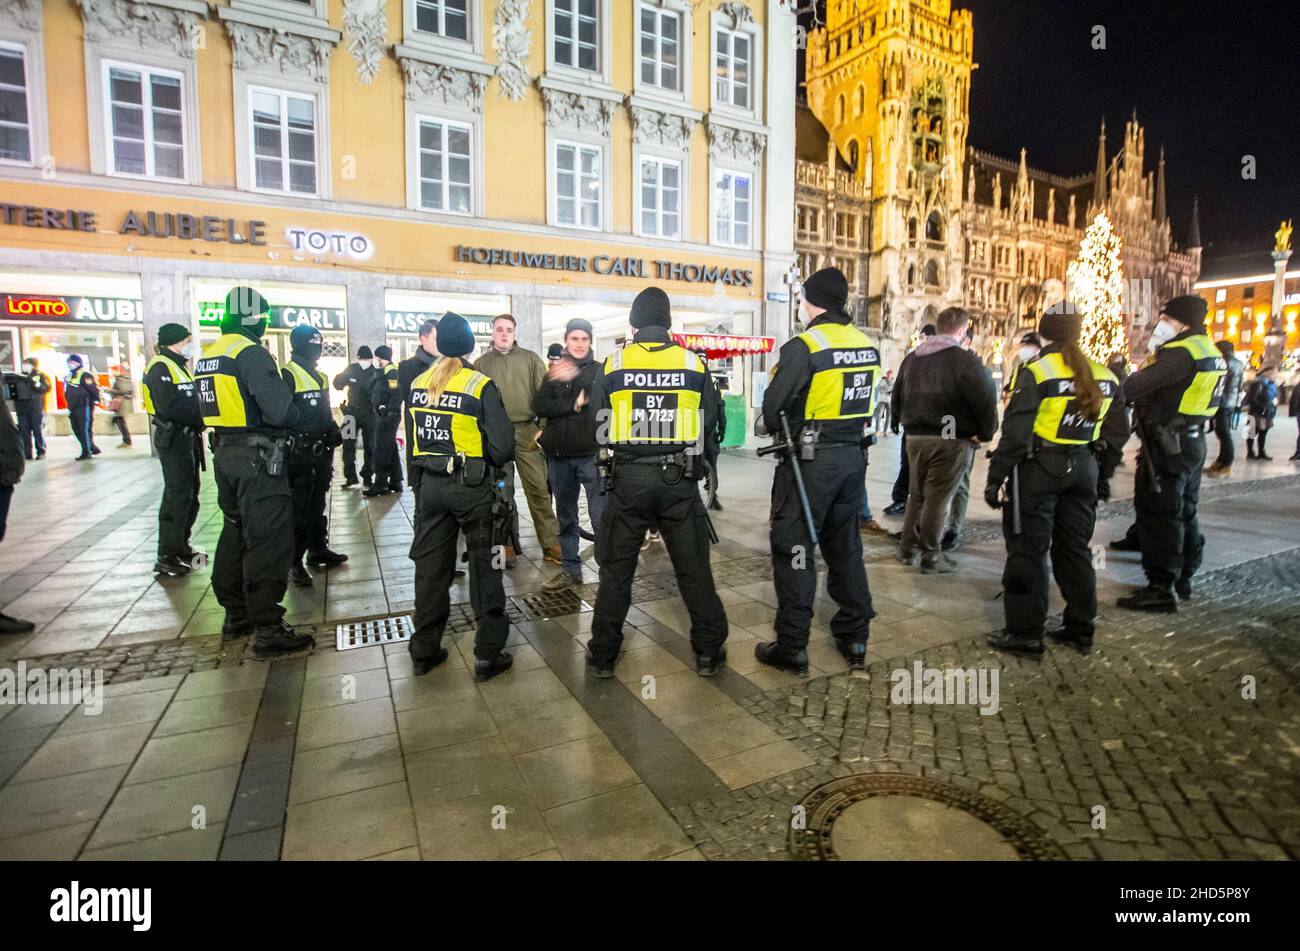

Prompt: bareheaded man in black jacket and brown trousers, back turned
[894,307,998,574]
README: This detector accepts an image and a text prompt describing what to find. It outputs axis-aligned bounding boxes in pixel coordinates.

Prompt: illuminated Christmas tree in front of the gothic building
[1066,214,1128,364]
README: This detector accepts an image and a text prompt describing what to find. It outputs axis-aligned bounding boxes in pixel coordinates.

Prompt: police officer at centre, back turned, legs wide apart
[586,287,727,678]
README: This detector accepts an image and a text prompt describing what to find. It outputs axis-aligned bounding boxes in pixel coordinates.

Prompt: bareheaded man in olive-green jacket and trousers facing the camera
[477,313,561,568]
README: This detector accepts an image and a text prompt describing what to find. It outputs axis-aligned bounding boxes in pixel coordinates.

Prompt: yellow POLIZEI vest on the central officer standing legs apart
[605,343,709,446]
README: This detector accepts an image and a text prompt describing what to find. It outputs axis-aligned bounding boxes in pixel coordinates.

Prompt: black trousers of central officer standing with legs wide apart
[588,463,727,665]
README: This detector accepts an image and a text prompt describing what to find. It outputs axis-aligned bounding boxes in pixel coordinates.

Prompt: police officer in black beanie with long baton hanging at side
[754,268,880,674]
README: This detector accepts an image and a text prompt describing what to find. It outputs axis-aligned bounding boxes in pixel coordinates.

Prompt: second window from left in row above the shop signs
[104,62,185,178]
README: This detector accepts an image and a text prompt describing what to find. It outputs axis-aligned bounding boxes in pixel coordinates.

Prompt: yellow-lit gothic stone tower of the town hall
[807,0,971,356]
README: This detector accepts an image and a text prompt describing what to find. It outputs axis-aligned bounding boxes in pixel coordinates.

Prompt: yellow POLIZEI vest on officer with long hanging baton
[798,323,880,420]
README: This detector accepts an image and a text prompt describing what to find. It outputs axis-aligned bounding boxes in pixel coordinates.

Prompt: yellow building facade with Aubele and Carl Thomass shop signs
[0,0,796,426]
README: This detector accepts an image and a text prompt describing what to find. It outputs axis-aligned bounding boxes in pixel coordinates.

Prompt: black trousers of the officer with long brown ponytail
[1002,446,1097,639]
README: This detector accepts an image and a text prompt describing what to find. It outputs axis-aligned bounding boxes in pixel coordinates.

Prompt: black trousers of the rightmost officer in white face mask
[1134,424,1205,587]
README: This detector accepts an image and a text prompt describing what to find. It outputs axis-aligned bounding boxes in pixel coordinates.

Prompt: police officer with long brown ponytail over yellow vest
[984,313,1127,655]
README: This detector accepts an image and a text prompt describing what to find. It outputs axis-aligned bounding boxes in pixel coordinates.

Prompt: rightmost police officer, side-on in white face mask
[1118,294,1227,613]
